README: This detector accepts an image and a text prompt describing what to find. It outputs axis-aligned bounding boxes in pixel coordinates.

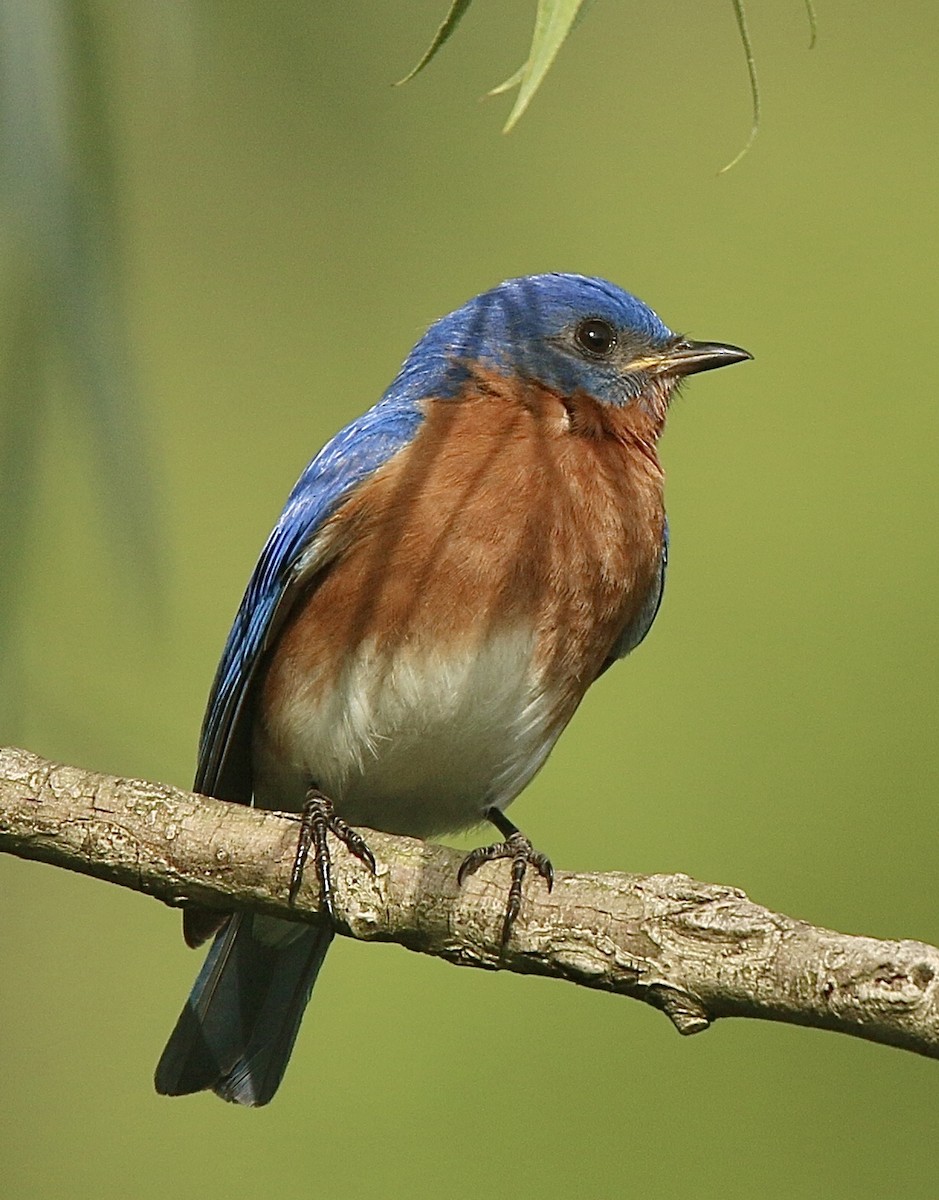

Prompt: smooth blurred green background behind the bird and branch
[0,0,939,1200]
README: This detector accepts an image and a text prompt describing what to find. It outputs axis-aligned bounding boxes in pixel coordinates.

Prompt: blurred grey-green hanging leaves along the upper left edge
[0,0,160,700]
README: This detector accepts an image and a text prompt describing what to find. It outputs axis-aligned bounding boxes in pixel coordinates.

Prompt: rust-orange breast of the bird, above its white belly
[256,372,664,739]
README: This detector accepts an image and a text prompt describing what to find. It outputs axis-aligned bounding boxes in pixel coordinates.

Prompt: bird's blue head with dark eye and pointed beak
[399,274,750,427]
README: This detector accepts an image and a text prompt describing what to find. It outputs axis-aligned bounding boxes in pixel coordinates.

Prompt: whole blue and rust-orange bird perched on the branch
[155,272,752,1105]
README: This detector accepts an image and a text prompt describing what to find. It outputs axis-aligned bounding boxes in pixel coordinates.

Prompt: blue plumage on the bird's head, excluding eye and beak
[389,274,676,404]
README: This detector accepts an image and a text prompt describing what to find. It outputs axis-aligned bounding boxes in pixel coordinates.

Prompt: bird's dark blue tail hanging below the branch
[155,912,333,1105]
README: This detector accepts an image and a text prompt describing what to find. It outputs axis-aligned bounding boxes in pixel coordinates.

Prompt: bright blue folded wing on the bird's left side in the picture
[193,394,423,804]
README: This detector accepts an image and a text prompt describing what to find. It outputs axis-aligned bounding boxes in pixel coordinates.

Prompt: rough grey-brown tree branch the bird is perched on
[0,749,939,1058]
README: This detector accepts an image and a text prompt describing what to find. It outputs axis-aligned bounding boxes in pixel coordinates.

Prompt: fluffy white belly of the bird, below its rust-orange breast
[255,631,563,836]
